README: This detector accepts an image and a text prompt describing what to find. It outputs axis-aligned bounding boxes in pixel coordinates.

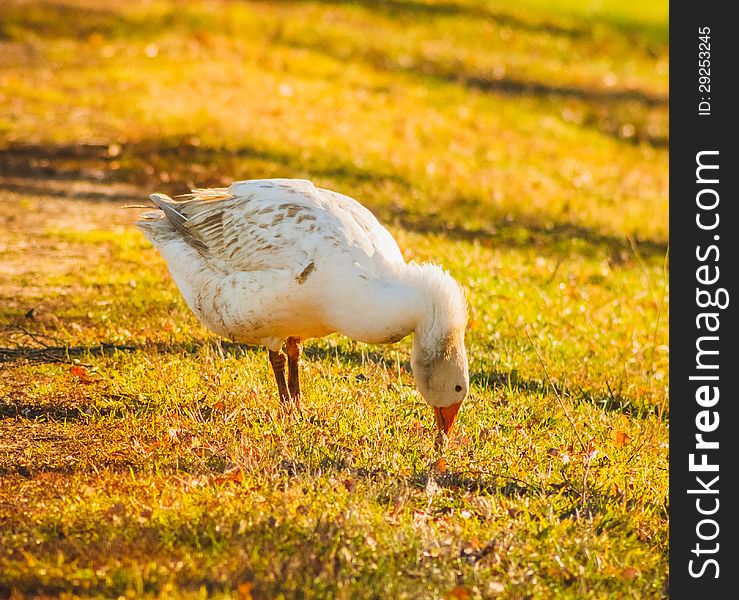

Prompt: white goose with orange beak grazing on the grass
[137,179,469,434]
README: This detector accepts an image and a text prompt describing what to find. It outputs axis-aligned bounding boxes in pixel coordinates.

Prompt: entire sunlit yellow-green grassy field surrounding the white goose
[0,0,669,599]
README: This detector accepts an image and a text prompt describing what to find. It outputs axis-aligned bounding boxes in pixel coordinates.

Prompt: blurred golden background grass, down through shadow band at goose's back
[0,0,668,248]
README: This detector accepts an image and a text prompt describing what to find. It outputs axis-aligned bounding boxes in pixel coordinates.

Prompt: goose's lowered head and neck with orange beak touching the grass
[411,264,470,434]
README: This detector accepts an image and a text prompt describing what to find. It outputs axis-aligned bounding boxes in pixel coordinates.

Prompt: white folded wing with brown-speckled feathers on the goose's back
[142,179,404,274]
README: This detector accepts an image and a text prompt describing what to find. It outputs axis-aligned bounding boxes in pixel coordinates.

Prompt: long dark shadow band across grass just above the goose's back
[0,138,667,262]
